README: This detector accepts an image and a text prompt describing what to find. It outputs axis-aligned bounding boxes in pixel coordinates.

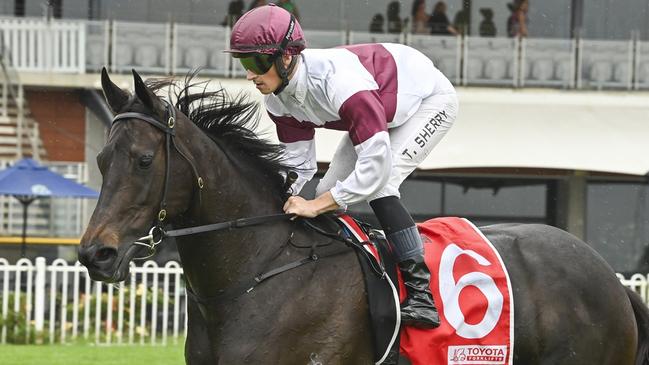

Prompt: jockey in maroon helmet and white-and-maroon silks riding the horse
[226,4,458,328]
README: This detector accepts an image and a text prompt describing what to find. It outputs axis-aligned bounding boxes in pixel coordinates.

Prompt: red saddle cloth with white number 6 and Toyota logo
[399,218,514,365]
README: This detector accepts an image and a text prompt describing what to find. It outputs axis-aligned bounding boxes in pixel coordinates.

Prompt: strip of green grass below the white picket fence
[0,341,185,365]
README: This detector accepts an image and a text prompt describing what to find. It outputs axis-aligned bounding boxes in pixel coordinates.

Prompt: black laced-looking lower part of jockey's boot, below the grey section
[399,255,440,328]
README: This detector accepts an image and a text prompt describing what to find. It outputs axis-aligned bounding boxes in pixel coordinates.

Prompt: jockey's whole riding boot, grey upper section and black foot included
[387,226,440,328]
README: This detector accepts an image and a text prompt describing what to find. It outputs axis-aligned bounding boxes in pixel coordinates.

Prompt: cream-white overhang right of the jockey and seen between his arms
[308,88,649,175]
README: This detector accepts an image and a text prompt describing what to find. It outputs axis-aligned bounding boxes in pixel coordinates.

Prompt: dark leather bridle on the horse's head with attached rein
[112,100,293,260]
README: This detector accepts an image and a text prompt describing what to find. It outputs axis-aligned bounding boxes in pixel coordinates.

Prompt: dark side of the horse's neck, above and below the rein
[177,119,290,296]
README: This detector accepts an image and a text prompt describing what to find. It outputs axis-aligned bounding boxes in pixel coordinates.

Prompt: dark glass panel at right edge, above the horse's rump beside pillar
[586,183,649,272]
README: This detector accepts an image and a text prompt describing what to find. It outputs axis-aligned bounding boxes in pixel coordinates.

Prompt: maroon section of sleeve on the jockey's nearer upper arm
[338,90,388,146]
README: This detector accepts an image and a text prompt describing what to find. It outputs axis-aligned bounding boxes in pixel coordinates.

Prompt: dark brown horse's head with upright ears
[79,69,192,282]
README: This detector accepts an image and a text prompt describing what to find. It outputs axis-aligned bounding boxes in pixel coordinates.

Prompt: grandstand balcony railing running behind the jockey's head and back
[0,18,649,89]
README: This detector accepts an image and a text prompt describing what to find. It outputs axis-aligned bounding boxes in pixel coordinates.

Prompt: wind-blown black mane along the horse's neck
[147,71,289,193]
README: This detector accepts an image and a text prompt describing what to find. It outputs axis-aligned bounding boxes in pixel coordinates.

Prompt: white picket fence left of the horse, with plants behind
[0,257,187,345]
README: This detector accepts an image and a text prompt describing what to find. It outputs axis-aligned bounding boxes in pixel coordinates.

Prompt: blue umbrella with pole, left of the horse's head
[0,158,99,257]
